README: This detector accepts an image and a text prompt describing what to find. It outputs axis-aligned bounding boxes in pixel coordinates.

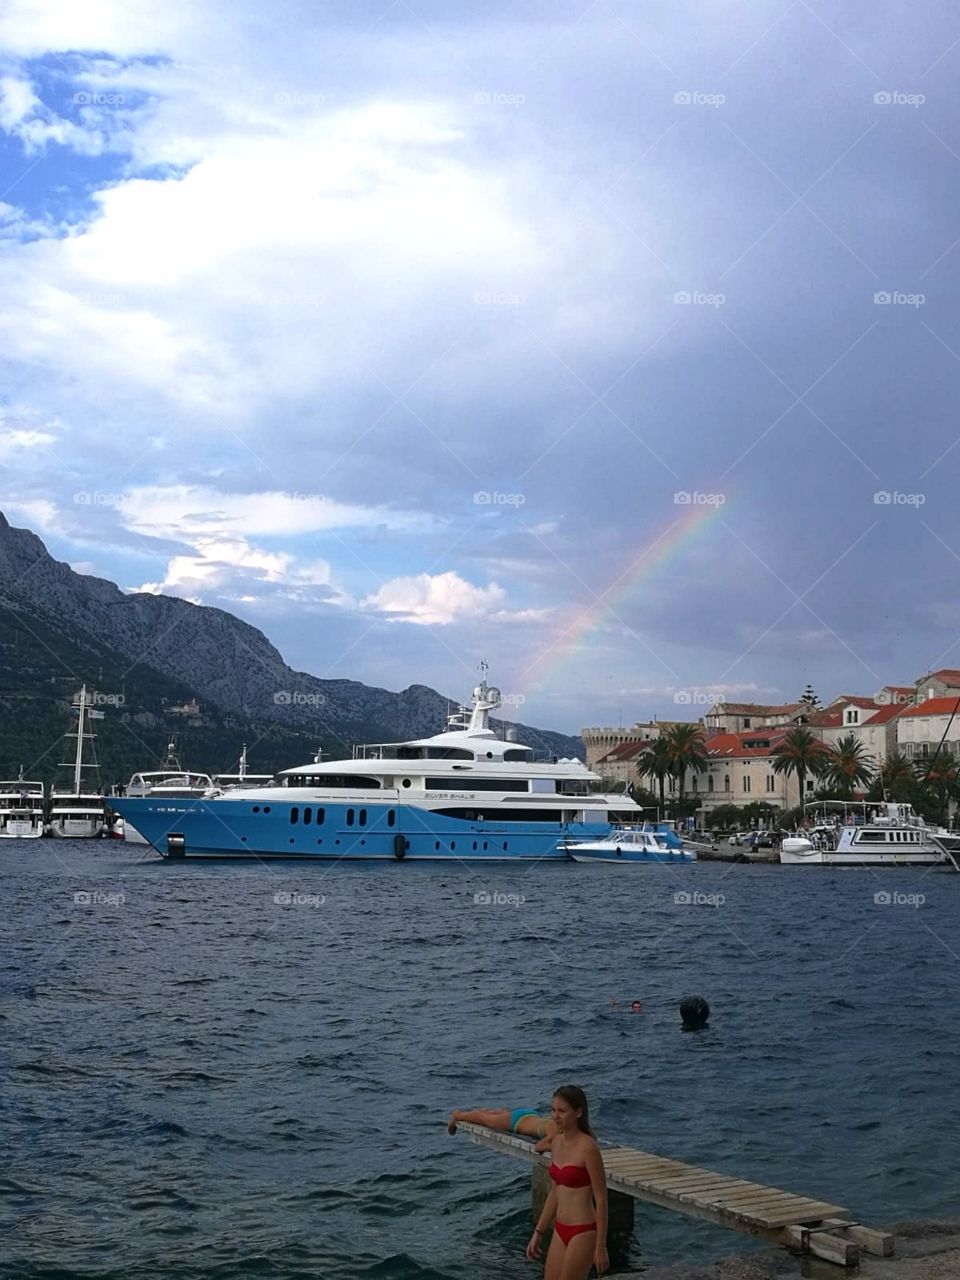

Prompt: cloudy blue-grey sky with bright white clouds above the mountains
[0,0,960,732]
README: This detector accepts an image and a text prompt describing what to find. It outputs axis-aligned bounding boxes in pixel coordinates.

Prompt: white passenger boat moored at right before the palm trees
[780,800,947,867]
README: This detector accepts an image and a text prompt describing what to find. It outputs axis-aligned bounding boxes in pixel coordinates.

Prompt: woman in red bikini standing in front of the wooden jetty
[526,1084,609,1280]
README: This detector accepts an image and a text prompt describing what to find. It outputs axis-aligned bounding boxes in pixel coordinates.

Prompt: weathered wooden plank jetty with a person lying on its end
[458,1121,893,1267]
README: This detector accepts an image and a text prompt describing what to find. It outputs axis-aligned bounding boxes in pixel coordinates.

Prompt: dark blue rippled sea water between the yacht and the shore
[0,841,960,1280]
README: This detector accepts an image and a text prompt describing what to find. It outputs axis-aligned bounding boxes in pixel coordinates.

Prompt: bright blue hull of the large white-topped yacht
[110,794,611,861]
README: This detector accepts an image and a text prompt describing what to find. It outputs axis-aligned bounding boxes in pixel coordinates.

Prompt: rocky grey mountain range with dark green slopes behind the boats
[0,513,584,781]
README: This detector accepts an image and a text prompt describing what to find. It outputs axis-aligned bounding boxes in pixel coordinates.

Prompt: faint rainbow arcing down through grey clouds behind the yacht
[521,494,728,692]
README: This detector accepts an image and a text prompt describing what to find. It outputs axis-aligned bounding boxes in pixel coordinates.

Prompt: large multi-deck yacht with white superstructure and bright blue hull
[114,664,640,861]
